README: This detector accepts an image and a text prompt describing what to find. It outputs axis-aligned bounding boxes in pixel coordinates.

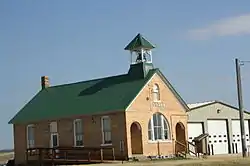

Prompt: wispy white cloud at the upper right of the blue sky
[188,14,250,40]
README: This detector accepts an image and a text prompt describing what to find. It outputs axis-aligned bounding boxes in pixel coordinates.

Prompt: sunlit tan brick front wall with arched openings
[126,74,187,156]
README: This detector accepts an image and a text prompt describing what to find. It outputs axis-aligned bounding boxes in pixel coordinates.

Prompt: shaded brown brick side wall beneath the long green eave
[14,112,127,164]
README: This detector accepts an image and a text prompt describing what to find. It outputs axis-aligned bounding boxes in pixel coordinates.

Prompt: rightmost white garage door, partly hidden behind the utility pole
[232,120,250,153]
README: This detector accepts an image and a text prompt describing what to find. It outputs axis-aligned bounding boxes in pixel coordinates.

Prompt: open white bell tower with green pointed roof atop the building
[124,33,155,78]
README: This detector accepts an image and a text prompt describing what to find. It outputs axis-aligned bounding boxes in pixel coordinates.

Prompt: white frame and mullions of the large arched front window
[148,114,172,143]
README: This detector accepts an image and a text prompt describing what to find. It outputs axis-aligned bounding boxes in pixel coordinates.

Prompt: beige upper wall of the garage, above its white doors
[188,102,250,121]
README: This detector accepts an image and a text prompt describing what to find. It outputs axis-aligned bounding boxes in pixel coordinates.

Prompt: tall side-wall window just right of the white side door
[74,119,83,146]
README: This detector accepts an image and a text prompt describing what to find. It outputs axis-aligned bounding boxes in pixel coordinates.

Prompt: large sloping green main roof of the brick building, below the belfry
[9,69,188,124]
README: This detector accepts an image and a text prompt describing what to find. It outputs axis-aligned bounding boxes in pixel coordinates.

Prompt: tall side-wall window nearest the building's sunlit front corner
[102,116,112,144]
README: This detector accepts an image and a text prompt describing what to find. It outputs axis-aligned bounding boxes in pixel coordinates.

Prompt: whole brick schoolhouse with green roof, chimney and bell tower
[9,34,188,164]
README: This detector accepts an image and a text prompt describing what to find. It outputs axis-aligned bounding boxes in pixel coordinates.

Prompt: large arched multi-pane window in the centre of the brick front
[148,113,170,141]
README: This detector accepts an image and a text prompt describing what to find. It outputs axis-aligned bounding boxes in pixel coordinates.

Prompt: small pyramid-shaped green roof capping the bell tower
[124,33,155,51]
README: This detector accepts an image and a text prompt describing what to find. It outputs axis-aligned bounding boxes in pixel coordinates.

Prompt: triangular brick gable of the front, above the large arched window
[127,70,189,112]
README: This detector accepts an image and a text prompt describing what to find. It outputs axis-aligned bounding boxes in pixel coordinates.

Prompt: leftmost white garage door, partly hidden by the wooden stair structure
[188,123,203,142]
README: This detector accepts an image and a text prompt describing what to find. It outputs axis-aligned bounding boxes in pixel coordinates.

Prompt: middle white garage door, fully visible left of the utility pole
[207,120,228,155]
